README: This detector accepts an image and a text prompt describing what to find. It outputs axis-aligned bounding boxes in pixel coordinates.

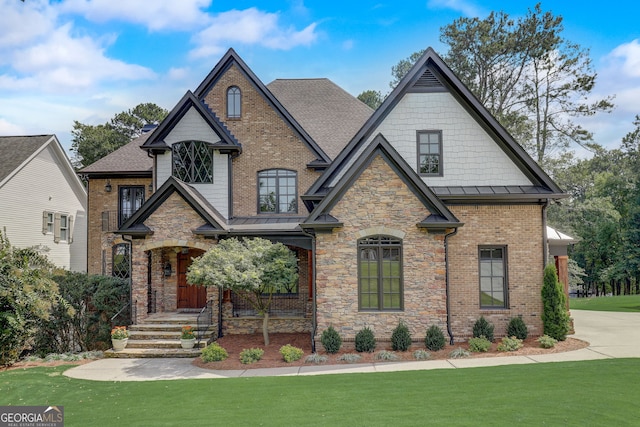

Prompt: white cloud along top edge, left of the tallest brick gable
[60,0,211,31]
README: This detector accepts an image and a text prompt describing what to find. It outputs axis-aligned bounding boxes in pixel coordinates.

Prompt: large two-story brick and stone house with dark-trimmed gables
[81,49,564,341]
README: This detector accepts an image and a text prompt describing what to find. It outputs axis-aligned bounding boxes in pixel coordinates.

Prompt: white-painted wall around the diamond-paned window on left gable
[156,108,229,218]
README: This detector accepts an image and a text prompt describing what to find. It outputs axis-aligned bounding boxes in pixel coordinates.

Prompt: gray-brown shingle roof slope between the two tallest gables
[267,78,373,160]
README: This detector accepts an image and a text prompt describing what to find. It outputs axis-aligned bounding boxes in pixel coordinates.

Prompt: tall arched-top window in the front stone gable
[358,236,403,311]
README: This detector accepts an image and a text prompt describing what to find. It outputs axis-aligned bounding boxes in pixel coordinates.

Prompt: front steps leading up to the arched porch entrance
[104,313,215,359]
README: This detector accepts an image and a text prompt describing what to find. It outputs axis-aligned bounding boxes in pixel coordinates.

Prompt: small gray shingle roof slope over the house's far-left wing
[79,131,153,174]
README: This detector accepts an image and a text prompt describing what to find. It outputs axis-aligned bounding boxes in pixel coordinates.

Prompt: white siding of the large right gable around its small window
[332,92,531,186]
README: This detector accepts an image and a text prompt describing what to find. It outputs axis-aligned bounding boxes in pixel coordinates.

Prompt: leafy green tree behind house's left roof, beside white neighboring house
[71,103,169,168]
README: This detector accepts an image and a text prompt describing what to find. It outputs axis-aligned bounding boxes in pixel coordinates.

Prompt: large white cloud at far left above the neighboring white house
[0,24,154,92]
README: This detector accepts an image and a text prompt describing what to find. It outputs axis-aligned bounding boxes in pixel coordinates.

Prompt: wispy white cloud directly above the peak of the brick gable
[190,8,317,58]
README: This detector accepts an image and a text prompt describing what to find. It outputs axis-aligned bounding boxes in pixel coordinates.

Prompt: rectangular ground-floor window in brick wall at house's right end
[478,246,508,308]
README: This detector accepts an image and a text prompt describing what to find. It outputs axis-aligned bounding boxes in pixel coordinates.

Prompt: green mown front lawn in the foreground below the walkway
[0,359,640,427]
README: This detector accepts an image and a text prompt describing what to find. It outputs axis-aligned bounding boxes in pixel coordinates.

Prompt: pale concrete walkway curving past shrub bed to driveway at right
[65,310,640,381]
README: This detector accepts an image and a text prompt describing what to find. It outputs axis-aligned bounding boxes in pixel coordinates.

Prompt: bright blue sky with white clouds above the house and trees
[0,0,640,157]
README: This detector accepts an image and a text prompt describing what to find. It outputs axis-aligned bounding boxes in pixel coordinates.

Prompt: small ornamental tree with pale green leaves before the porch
[187,238,298,345]
